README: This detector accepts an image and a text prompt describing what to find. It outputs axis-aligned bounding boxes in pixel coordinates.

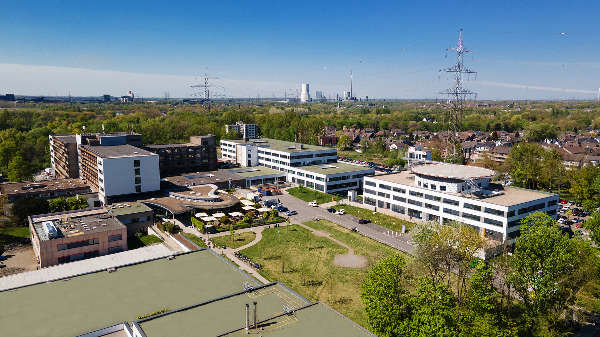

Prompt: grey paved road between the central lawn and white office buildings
[277,194,414,254]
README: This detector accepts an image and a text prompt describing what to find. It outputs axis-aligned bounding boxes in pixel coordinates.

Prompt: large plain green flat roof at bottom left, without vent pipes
[0,250,252,336]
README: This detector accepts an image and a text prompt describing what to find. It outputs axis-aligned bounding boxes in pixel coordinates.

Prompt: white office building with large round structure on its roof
[363,163,559,242]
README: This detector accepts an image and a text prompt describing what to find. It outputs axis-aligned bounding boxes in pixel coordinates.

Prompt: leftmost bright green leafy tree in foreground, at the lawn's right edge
[360,254,409,336]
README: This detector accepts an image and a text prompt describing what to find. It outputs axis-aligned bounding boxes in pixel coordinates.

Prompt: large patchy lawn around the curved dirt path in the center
[241,220,398,327]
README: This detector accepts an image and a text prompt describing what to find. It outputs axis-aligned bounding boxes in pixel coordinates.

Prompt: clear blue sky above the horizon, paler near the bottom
[0,0,600,100]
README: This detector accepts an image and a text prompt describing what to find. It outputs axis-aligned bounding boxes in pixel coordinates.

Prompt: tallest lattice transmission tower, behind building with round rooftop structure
[436,29,477,163]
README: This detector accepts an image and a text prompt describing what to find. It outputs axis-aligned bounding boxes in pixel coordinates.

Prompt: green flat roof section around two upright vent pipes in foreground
[138,284,312,337]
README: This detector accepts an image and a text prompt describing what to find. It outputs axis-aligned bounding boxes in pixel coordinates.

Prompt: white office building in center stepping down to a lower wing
[221,138,375,193]
